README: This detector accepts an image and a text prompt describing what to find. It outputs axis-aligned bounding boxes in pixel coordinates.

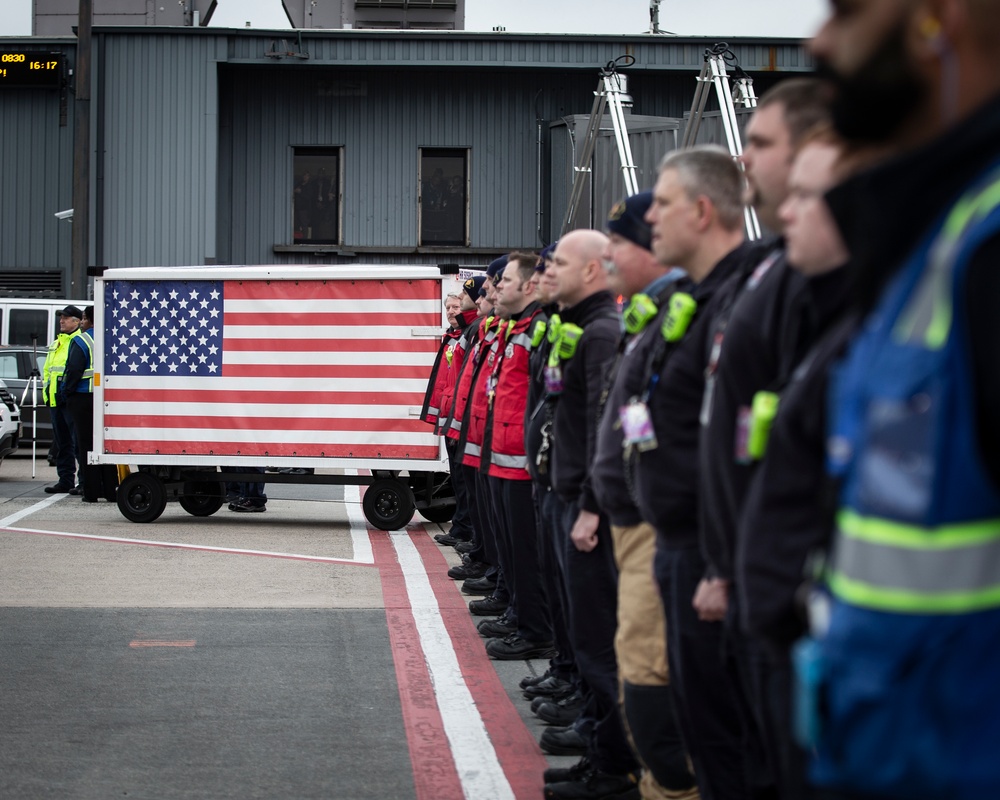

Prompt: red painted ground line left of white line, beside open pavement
[368,528,466,800]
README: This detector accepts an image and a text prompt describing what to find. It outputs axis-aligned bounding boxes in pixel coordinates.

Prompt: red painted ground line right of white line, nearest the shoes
[408,530,549,800]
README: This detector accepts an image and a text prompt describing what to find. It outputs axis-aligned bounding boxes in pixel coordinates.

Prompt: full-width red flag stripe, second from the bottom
[104,413,429,434]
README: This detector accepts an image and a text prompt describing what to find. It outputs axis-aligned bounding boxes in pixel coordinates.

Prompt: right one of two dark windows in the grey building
[420,147,469,246]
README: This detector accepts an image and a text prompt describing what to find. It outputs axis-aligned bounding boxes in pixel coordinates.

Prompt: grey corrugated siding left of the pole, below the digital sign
[0,46,73,283]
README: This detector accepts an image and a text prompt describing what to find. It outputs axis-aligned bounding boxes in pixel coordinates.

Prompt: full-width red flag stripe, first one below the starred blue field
[104,390,424,406]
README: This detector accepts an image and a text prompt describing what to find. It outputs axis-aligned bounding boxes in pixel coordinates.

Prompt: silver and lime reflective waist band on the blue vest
[829,510,1000,614]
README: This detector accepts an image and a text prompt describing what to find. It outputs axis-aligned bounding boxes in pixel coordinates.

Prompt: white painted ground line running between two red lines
[389,531,515,800]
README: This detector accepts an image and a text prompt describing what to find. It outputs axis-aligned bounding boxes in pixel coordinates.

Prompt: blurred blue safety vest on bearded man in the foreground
[812,170,1000,800]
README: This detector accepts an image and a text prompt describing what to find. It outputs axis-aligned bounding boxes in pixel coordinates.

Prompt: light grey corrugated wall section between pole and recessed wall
[95,35,225,267]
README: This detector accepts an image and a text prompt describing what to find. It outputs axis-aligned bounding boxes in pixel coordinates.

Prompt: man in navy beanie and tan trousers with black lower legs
[591,191,698,800]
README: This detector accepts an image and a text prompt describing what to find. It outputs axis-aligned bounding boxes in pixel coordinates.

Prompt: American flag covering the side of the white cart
[103,279,442,459]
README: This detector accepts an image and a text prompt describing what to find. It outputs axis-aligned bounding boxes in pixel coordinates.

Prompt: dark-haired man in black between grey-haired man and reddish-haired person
[695,78,832,798]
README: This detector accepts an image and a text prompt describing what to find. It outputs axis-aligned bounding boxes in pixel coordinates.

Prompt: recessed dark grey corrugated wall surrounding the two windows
[220,69,616,263]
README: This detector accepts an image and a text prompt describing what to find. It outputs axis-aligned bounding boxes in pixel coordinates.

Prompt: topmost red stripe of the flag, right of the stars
[225,278,441,300]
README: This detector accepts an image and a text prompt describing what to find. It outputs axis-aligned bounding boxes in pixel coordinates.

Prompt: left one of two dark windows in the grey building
[292,147,341,244]
